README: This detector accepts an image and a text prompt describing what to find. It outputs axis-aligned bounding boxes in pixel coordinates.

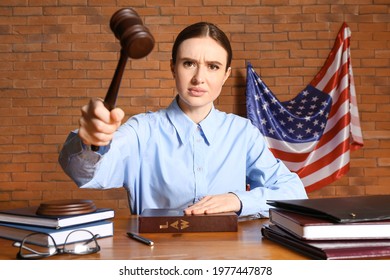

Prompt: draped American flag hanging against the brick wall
[246,23,363,192]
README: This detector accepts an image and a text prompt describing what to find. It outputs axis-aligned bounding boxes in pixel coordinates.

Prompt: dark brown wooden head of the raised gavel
[110,8,154,59]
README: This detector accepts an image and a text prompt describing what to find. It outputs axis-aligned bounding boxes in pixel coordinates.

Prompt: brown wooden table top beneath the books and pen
[0,216,307,260]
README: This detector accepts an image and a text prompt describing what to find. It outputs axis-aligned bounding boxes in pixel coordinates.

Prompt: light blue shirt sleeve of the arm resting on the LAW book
[235,123,307,218]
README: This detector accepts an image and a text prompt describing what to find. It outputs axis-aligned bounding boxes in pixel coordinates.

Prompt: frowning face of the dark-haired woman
[171,37,231,122]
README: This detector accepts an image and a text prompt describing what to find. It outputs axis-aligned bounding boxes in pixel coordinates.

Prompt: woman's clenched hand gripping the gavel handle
[79,99,125,146]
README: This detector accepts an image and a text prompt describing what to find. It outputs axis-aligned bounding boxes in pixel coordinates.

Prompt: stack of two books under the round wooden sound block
[0,201,114,245]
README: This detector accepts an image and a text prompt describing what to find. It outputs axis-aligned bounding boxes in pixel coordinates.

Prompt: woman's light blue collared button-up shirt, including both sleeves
[59,99,307,217]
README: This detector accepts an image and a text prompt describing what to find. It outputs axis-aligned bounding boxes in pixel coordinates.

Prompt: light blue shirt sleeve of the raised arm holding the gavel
[58,118,145,189]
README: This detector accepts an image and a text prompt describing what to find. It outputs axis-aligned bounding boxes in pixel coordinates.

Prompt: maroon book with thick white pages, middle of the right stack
[269,208,390,240]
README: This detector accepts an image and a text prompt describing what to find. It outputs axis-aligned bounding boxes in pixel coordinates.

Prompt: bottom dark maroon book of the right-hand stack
[261,224,390,260]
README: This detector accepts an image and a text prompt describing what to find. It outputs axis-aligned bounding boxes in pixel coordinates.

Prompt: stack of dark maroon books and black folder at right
[261,195,390,259]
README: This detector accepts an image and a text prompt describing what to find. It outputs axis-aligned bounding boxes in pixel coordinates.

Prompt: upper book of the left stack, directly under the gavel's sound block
[0,206,115,228]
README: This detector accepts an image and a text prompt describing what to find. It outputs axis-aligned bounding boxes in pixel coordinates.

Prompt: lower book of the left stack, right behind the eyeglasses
[0,220,114,246]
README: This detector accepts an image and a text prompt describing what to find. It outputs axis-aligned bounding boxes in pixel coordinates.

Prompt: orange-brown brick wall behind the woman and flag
[0,0,390,215]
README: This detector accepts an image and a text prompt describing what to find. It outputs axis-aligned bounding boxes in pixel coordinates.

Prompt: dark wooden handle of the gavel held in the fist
[91,49,128,152]
